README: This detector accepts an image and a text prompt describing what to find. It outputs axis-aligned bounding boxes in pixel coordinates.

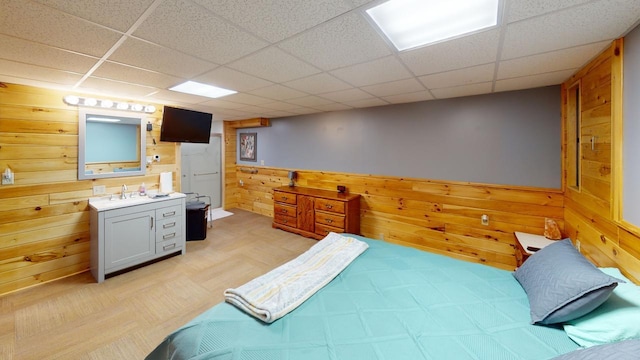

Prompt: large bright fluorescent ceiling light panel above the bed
[367,0,501,51]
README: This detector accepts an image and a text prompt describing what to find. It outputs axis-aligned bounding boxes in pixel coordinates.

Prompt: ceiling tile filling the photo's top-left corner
[0,0,122,57]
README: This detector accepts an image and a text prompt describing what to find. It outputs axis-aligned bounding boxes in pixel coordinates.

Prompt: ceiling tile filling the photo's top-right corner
[501,0,640,59]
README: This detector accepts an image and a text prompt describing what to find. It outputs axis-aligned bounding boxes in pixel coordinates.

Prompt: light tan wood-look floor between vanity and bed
[0,209,316,359]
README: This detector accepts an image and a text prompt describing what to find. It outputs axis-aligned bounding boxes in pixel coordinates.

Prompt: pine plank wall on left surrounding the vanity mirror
[0,83,180,295]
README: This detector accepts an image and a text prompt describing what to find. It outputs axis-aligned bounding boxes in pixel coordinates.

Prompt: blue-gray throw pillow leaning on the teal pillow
[513,239,622,324]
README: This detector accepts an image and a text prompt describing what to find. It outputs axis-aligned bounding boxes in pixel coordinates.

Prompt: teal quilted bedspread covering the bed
[147,235,578,360]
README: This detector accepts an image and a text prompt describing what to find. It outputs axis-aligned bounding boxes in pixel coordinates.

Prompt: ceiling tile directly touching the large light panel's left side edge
[279,12,391,70]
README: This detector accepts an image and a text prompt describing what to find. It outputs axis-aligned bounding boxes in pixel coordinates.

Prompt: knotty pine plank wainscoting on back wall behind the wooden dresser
[225,128,564,270]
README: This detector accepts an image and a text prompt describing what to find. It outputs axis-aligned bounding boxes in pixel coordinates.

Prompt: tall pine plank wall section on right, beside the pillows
[562,39,640,282]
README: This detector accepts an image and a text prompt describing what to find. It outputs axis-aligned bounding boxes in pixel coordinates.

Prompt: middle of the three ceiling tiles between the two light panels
[229,47,320,82]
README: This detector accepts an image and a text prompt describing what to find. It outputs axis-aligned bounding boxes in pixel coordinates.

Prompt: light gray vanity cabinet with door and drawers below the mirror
[90,197,186,282]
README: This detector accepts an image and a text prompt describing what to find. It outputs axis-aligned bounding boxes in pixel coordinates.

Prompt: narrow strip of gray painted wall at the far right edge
[622,27,640,226]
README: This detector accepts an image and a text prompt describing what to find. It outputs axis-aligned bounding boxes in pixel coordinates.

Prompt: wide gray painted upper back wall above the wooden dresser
[237,86,561,188]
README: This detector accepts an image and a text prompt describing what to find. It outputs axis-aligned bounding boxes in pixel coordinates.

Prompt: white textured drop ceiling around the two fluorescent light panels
[0,0,640,120]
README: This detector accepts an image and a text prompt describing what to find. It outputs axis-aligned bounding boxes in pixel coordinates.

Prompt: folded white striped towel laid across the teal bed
[224,233,369,323]
